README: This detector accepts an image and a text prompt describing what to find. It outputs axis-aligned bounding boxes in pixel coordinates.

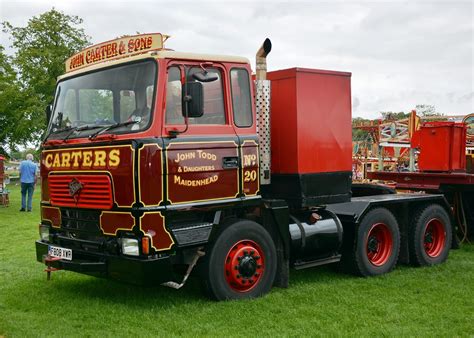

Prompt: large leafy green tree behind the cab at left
[0,8,90,151]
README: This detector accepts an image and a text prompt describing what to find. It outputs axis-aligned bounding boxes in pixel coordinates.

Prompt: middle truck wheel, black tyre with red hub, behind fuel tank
[341,208,400,276]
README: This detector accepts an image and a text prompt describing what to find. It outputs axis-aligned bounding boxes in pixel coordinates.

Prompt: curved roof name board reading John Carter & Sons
[66,33,168,73]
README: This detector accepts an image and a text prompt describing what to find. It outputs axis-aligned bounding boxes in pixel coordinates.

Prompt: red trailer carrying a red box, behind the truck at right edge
[367,117,474,241]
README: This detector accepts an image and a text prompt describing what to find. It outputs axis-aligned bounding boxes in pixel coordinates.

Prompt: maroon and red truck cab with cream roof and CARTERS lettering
[37,34,259,290]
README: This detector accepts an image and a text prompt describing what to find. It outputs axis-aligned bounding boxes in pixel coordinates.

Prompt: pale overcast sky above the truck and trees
[0,0,474,118]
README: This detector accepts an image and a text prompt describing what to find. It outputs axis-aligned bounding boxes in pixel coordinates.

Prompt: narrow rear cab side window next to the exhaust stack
[230,68,253,127]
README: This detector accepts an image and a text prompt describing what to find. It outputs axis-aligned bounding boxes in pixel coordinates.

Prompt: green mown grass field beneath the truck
[0,187,474,337]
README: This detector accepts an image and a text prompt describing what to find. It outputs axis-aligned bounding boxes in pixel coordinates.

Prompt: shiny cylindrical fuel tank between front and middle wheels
[290,209,343,261]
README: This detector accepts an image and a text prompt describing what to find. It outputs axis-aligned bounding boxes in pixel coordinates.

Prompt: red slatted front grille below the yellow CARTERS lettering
[48,175,113,210]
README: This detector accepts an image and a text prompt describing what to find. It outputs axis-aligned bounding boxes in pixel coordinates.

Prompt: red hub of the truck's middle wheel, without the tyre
[366,223,393,266]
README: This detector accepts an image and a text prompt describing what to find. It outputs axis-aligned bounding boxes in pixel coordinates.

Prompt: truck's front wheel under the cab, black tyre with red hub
[201,220,277,300]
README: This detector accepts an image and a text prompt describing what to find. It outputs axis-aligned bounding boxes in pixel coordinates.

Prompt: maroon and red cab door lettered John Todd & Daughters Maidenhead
[163,63,240,208]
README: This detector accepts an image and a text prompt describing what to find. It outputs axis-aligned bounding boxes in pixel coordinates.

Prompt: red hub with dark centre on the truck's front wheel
[224,240,265,292]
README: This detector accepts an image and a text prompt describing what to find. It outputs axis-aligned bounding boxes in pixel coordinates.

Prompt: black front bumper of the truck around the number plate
[36,240,175,286]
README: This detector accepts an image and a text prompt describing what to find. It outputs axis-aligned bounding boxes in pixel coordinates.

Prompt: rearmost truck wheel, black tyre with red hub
[409,204,452,266]
